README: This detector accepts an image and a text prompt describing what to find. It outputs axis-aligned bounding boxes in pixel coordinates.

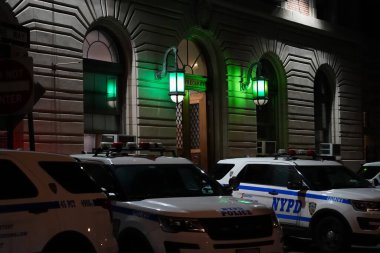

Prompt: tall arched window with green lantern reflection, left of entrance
[83,29,123,152]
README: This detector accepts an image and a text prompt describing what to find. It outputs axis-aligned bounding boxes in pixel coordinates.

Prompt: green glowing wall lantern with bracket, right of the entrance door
[240,62,269,106]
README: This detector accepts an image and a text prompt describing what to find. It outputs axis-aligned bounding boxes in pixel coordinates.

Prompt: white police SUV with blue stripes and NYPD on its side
[215,151,380,252]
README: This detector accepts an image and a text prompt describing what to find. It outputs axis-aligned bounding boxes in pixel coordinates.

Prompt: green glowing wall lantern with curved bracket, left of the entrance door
[156,47,185,104]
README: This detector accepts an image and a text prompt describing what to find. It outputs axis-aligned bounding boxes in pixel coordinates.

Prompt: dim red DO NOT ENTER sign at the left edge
[0,59,34,115]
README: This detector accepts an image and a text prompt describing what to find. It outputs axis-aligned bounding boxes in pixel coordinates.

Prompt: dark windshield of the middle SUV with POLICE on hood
[113,164,223,200]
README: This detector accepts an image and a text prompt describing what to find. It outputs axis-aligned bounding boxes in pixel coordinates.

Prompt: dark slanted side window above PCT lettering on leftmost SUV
[39,161,101,193]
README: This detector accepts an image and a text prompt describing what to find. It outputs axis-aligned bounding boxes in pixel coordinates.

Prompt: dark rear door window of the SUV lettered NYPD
[237,164,272,185]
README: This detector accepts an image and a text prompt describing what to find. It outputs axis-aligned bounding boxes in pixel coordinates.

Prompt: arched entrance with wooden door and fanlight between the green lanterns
[177,40,208,170]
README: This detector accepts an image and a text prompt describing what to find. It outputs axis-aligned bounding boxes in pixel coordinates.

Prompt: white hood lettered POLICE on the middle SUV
[114,196,272,218]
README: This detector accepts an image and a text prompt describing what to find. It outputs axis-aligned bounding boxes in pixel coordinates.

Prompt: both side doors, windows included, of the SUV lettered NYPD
[238,164,302,225]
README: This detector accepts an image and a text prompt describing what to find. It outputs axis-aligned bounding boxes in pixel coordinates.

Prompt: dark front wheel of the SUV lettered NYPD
[314,216,350,253]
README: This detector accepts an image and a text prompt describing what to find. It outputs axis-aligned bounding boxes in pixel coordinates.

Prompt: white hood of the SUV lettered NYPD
[327,188,380,201]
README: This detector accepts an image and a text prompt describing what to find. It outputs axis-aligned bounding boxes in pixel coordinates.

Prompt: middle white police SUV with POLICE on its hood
[72,144,283,253]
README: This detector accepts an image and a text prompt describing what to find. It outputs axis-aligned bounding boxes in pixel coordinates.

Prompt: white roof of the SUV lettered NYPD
[218,157,342,166]
